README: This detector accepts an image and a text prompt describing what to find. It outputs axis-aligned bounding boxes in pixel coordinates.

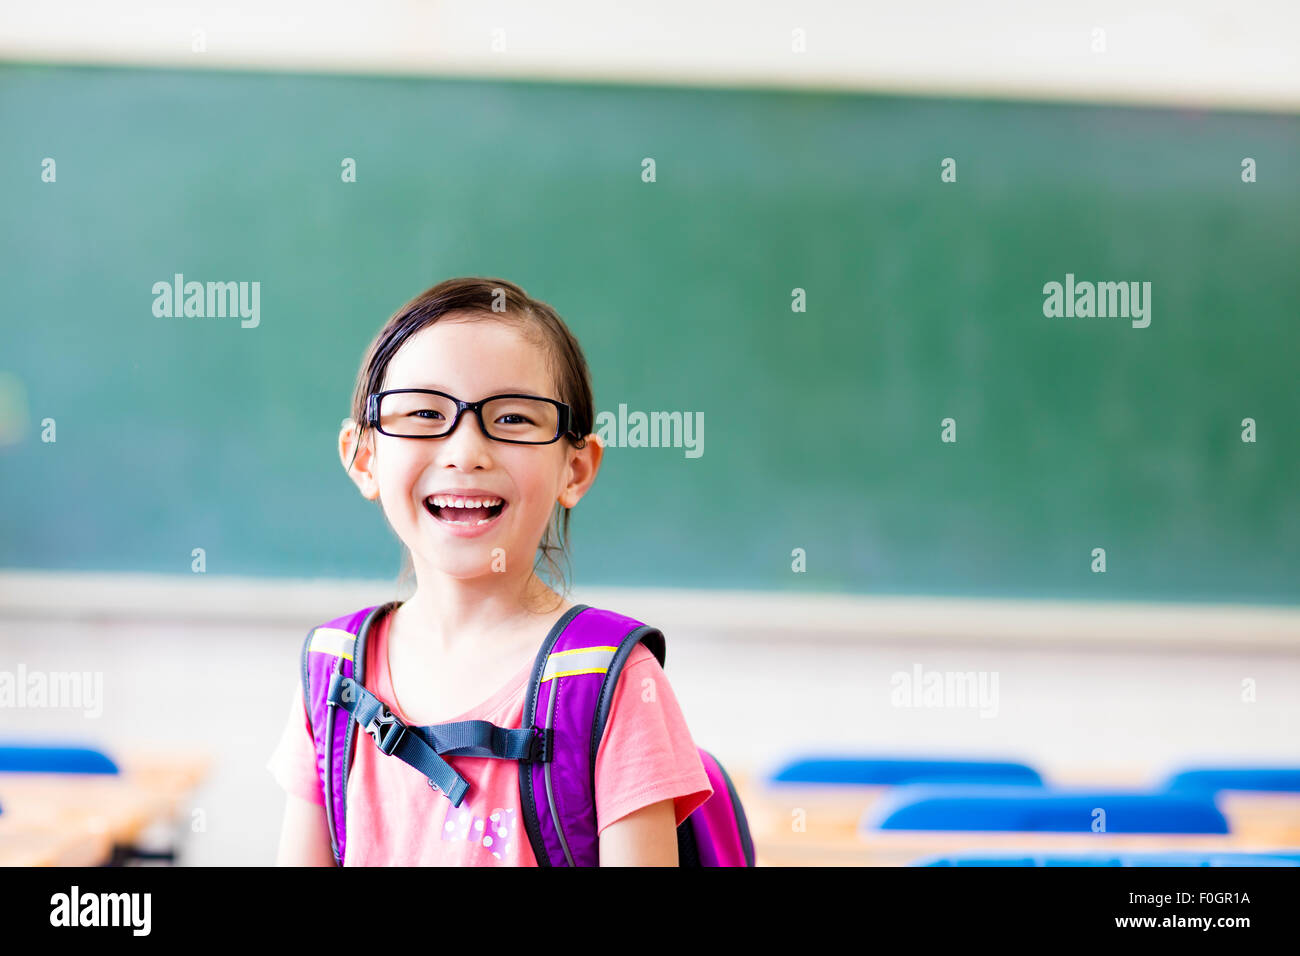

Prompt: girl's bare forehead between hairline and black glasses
[384,319,550,401]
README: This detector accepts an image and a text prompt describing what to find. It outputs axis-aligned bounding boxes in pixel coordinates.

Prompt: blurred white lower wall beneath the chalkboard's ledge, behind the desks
[0,619,1300,865]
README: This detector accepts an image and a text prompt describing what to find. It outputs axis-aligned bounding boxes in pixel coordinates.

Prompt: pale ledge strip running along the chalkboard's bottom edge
[0,571,1300,653]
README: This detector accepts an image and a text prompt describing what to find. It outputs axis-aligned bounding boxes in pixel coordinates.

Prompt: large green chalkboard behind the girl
[0,64,1300,602]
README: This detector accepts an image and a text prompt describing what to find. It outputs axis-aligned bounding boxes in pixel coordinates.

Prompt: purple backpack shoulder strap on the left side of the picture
[303,601,400,865]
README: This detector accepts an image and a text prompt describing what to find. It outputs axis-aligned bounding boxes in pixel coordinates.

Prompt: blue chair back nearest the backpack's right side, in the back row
[768,757,1043,787]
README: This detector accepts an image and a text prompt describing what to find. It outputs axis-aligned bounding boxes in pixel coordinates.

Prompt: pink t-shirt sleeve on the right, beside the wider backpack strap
[595,644,714,834]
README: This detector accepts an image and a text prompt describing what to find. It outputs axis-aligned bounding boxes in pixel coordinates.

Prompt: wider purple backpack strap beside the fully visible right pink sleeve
[519,605,664,866]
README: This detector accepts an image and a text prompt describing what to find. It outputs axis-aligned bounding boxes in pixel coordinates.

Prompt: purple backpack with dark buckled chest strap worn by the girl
[303,601,754,866]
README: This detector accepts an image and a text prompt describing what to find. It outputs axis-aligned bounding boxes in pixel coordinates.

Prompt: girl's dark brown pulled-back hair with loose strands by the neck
[347,276,595,594]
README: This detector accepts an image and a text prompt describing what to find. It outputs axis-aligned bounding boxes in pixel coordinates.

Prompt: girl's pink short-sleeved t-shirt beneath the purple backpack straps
[267,615,714,866]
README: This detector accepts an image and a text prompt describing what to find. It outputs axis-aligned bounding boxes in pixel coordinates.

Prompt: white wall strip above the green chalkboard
[0,0,1300,111]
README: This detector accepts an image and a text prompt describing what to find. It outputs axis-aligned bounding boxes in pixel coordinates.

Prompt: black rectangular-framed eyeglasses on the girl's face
[365,389,577,445]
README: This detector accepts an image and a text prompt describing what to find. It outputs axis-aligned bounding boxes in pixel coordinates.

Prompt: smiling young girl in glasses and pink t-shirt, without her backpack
[268,278,712,866]
